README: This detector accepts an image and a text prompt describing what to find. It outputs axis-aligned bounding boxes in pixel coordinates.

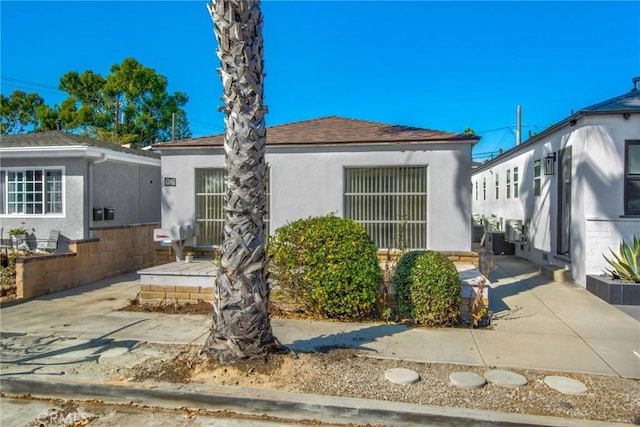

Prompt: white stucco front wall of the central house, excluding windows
[162,143,471,251]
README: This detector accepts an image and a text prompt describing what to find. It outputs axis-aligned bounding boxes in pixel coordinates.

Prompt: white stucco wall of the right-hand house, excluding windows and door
[472,115,640,286]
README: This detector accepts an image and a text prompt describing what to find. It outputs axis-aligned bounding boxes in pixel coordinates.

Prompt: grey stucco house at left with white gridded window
[0,131,160,251]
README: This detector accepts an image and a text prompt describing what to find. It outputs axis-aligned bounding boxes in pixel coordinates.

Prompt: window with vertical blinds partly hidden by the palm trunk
[196,168,270,246]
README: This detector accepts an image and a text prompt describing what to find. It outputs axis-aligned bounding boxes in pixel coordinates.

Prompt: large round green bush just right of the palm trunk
[268,215,381,319]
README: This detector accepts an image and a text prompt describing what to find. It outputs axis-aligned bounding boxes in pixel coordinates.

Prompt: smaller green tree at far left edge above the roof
[0,90,44,135]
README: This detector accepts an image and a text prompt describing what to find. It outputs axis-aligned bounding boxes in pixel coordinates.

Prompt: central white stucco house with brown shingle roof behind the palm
[154,116,479,251]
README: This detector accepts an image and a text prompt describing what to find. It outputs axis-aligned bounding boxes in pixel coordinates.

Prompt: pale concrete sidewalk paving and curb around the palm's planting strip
[0,256,640,425]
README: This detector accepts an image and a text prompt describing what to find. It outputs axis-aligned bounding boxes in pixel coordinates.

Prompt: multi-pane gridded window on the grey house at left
[2,169,63,215]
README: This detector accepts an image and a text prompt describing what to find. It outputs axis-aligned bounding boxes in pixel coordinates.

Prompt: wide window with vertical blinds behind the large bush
[344,166,427,249]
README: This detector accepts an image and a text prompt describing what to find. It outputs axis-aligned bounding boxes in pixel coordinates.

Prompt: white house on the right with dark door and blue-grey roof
[472,78,640,286]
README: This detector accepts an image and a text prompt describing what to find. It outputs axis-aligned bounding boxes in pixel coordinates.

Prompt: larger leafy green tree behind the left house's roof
[59,58,191,146]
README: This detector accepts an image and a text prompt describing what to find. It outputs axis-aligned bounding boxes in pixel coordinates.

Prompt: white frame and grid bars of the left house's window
[0,166,67,218]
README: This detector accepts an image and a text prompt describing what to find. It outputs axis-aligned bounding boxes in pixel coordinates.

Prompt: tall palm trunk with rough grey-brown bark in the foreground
[202,0,278,362]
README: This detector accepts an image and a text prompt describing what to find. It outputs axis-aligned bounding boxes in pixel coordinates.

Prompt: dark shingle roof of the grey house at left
[0,130,160,158]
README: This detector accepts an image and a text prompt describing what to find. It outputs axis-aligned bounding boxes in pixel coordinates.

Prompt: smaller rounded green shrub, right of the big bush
[410,251,461,326]
